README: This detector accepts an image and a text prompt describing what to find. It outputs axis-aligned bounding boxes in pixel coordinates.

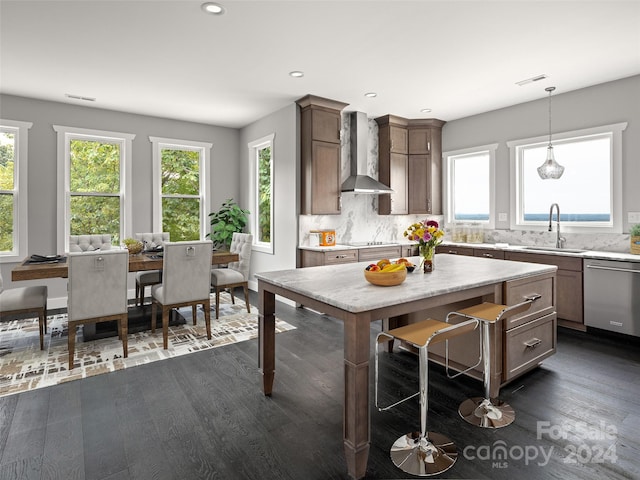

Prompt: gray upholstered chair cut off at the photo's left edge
[0,273,47,350]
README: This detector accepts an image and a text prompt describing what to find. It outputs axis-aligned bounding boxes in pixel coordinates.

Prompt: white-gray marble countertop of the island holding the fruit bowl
[255,255,557,313]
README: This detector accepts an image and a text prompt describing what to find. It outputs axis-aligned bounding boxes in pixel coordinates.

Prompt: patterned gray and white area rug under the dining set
[0,292,295,396]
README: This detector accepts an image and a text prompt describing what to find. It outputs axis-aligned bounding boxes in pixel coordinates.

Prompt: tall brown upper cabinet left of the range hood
[296,95,348,215]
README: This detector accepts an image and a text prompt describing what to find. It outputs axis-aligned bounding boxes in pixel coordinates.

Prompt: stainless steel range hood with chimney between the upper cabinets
[341,112,393,194]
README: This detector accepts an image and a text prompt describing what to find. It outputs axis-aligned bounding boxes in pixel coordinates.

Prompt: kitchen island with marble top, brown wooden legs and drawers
[256,255,557,478]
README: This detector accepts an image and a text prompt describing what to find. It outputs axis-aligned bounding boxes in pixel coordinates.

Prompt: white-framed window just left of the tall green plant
[149,137,212,242]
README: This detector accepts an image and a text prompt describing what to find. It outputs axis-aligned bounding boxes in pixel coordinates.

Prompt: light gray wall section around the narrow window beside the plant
[240,103,298,288]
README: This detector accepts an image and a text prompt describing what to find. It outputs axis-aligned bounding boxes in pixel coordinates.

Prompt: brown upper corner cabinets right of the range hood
[376,115,445,215]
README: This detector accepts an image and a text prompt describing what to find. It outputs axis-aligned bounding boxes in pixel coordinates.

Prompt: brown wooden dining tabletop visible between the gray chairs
[11,250,240,282]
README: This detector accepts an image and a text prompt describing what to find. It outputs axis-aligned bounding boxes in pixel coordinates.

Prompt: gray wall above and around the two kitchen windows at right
[442,76,640,232]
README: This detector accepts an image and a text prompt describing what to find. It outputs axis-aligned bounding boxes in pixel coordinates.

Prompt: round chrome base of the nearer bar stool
[391,432,458,477]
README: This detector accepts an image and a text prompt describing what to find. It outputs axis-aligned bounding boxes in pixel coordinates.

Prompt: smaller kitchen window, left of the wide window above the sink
[443,143,498,228]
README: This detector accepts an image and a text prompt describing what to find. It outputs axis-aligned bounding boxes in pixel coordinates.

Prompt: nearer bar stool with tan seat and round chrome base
[375,318,478,477]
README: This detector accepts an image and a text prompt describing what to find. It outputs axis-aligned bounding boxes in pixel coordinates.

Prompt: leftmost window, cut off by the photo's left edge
[0,119,33,262]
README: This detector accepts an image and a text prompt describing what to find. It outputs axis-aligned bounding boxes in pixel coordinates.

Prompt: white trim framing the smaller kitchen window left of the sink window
[442,143,498,229]
